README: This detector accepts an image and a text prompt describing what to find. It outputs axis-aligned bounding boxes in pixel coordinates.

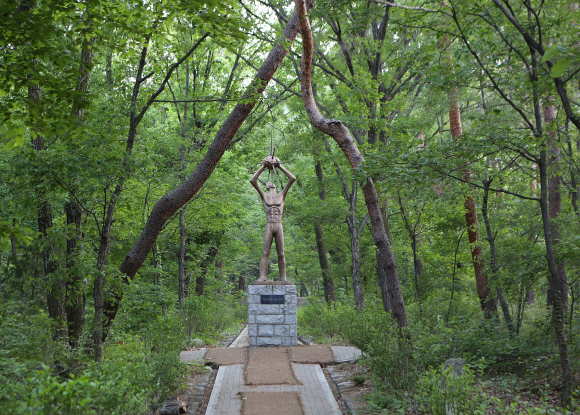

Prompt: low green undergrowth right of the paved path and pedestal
[298,296,580,414]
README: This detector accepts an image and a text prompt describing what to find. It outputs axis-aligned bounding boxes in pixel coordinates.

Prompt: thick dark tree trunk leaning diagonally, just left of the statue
[105,2,312,330]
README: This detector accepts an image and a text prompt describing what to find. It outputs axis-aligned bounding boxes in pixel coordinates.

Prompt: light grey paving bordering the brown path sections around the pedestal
[181,327,361,415]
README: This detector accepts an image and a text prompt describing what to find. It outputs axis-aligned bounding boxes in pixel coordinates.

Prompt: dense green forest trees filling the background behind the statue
[0,0,580,413]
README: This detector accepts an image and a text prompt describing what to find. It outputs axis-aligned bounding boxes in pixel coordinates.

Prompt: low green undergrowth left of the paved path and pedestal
[0,289,247,415]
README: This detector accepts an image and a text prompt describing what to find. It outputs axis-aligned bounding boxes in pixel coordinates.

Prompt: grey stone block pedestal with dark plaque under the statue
[248,281,297,347]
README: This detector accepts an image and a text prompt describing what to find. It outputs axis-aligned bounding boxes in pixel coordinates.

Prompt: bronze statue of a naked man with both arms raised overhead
[250,156,296,281]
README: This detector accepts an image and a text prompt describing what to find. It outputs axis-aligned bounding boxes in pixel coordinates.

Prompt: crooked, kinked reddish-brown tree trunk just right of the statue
[296,0,407,327]
